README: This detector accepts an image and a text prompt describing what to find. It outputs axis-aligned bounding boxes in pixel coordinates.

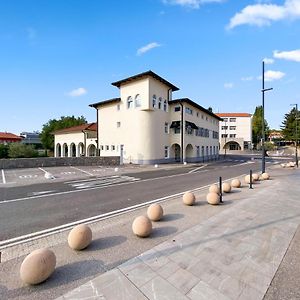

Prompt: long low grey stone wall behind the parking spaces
[0,156,120,169]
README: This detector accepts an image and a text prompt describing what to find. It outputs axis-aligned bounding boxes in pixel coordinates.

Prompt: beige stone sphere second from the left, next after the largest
[68,224,93,250]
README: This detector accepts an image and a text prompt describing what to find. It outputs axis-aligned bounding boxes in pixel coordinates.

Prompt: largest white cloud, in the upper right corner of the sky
[227,0,300,29]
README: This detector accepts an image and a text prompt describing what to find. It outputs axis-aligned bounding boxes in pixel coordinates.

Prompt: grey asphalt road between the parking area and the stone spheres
[0,158,276,241]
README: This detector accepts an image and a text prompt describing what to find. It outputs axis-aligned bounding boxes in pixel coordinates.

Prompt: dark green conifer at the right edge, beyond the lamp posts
[281,107,300,141]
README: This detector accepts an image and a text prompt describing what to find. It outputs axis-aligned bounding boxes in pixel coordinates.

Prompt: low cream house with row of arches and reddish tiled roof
[52,123,97,157]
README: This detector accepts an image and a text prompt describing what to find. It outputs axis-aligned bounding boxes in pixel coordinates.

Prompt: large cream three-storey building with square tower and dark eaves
[90,71,221,164]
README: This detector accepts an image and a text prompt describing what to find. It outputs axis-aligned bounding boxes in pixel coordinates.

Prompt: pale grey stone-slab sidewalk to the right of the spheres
[58,170,300,300]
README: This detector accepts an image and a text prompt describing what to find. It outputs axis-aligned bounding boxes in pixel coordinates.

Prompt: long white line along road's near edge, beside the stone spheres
[0,173,247,250]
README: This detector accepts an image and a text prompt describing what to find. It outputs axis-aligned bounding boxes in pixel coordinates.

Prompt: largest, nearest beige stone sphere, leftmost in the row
[20,248,56,284]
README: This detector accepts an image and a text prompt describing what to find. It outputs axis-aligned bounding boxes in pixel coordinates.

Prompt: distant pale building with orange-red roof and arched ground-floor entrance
[216,113,252,151]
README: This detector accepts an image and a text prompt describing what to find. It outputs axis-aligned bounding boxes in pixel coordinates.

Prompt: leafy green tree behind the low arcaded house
[40,116,87,151]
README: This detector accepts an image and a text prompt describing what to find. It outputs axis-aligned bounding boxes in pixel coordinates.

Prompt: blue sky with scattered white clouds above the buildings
[0,0,300,134]
